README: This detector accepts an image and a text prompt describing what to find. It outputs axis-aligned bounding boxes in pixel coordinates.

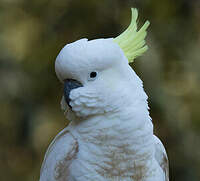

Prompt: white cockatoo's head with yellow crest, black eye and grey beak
[55,9,149,117]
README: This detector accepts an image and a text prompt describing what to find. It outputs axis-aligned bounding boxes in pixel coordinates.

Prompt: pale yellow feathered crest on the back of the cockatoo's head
[114,8,150,63]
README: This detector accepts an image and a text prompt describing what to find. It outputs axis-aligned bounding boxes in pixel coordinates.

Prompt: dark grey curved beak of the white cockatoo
[64,79,83,108]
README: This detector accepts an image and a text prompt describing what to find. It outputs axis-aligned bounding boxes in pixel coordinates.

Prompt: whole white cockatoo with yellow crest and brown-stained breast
[40,8,169,181]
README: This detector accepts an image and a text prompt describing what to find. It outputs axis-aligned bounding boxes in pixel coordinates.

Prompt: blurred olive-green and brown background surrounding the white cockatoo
[0,0,200,181]
